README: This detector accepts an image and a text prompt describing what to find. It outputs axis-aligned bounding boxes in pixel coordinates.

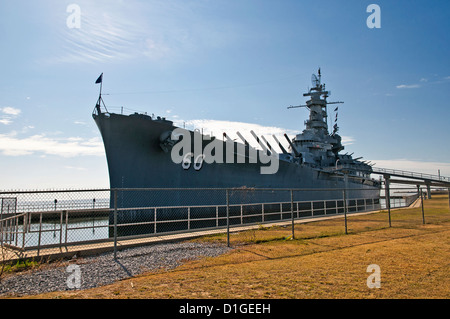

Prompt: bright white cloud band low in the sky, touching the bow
[0,133,104,157]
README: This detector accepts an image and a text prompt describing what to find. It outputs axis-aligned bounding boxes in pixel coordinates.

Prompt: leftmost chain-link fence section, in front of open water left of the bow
[0,189,110,254]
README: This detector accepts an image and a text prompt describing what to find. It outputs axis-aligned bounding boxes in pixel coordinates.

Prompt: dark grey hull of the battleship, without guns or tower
[94,113,379,207]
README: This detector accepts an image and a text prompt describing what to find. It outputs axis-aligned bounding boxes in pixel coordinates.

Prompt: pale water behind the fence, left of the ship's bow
[0,191,109,247]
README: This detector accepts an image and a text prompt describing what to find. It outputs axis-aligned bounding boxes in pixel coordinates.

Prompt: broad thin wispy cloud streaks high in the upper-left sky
[51,0,236,63]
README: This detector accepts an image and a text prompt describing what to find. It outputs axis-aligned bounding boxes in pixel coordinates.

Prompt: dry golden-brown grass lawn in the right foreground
[12,196,450,299]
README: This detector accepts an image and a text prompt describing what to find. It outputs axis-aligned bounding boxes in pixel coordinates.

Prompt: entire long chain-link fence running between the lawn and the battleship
[0,188,446,262]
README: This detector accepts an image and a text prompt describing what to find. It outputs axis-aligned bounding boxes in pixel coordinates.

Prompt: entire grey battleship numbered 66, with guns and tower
[92,69,381,235]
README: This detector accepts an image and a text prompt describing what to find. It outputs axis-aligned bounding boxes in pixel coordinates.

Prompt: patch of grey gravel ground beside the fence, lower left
[0,243,229,296]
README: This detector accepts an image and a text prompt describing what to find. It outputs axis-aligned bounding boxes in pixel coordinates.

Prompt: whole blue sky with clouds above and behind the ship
[0,0,450,190]
